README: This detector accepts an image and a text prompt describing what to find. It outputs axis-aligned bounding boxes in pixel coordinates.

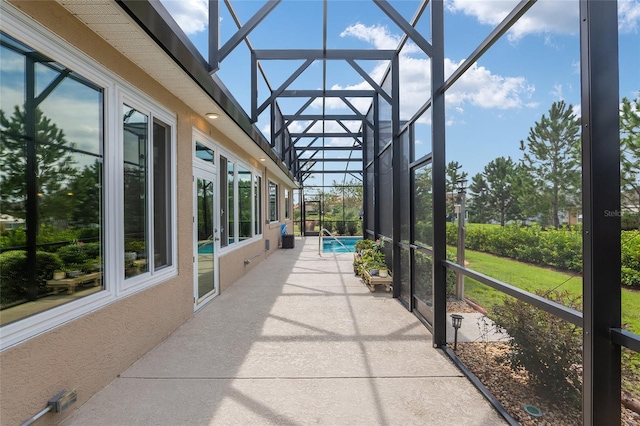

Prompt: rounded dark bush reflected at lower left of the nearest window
[0,250,62,305]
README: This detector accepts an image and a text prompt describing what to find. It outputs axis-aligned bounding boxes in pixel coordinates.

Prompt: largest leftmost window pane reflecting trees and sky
[0,32,104,326]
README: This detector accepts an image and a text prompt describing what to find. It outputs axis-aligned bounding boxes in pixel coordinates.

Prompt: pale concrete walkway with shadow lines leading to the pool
[63,237,506,426]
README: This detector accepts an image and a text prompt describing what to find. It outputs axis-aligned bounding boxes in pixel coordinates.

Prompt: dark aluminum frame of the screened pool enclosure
[116,0,640,425]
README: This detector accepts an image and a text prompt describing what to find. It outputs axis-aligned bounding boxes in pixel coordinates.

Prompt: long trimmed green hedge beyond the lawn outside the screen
[447,223,640,287]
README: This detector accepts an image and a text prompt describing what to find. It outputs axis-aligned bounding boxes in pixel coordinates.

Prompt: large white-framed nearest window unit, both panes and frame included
[0,20,176,350]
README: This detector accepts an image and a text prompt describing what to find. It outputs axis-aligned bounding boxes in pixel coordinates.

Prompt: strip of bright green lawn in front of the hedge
[465,250,640,333]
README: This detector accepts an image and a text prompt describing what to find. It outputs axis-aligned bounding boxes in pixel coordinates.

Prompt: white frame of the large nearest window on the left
[0,5,178,352]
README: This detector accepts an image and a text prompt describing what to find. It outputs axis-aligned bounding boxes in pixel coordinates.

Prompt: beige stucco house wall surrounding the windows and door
[0,0,296,425]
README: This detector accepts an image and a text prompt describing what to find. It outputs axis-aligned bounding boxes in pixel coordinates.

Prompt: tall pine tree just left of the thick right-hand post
[520,101,580,228]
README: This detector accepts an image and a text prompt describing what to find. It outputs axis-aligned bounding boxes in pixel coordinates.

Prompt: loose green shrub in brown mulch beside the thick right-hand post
[490,291,582,405]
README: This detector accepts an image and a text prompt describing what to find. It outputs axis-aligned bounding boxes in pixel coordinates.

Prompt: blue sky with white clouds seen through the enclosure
[162,0,640,180]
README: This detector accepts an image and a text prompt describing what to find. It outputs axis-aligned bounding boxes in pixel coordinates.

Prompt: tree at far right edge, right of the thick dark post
[620,94,640,228]
